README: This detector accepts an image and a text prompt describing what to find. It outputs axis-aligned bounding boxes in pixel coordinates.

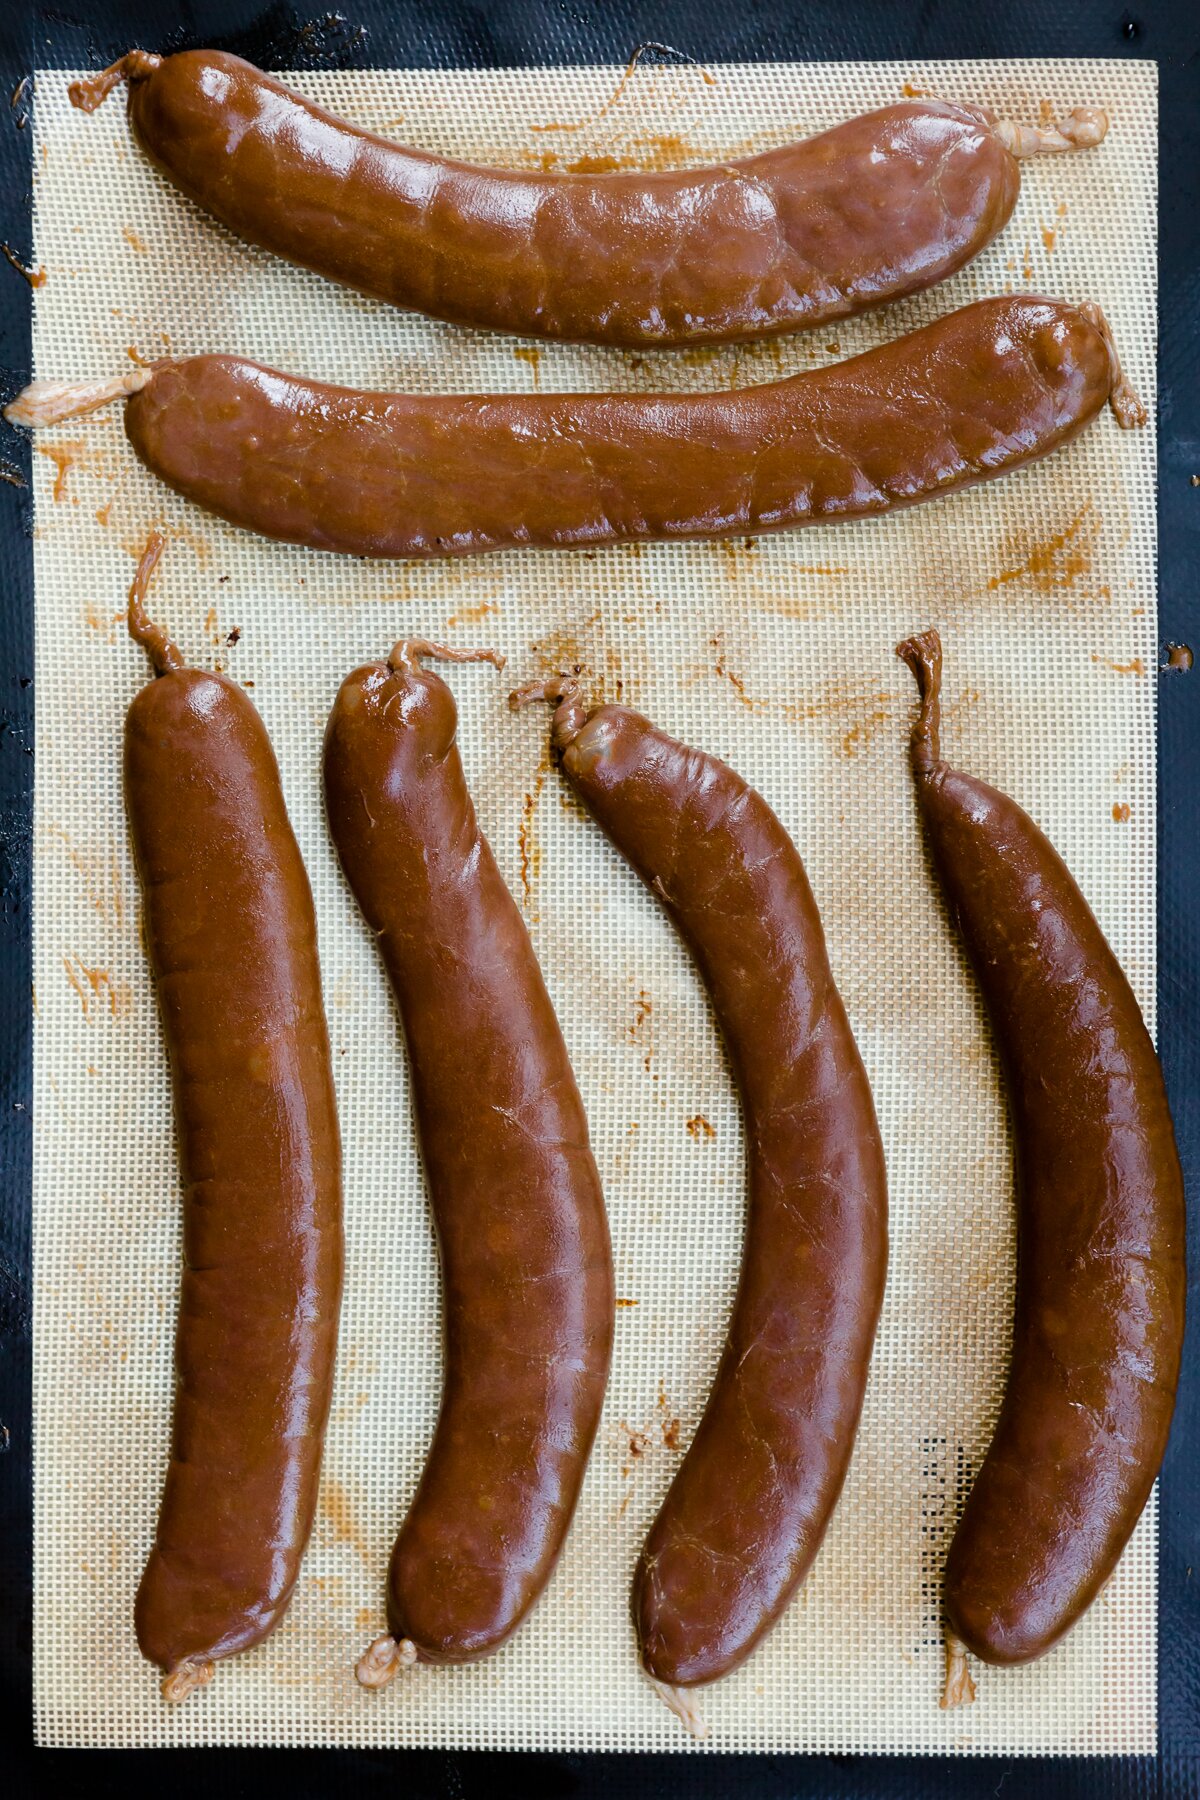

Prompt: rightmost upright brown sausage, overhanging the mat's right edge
[898,632,1186,1705]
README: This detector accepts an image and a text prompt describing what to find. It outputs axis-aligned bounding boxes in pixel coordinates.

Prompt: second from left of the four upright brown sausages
[324,641,615,1687]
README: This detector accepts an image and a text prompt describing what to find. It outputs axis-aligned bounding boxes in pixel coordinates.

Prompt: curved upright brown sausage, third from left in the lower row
[513,677,887,1723]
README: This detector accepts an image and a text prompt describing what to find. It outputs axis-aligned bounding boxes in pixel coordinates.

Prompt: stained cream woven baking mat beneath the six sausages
[34,61,1157,1753]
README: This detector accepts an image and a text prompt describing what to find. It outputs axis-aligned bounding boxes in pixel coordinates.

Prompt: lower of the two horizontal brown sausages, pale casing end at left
[5,295,1146,556]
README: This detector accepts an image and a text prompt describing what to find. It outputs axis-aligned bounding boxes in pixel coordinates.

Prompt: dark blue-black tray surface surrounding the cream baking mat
[0,0,1200,1800]
